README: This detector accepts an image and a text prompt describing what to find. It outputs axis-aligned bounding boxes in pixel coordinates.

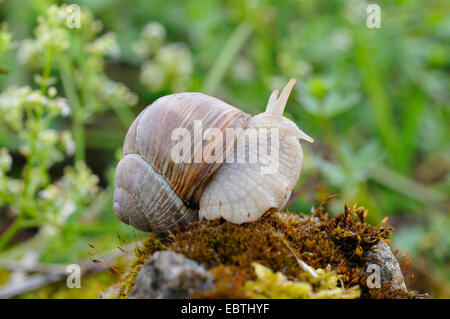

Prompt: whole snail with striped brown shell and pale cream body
[113,79,313,234]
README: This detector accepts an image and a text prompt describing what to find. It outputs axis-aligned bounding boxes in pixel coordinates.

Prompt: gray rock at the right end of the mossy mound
[364,240,407,291]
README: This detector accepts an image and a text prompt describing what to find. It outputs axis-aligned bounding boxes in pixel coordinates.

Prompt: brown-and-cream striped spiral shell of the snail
[114,93,250,233]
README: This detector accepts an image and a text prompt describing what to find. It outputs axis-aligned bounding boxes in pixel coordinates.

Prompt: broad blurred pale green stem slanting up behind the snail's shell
[202,23,252,94]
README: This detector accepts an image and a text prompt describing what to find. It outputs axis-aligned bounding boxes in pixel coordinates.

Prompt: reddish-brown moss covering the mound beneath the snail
[119,205,418,298]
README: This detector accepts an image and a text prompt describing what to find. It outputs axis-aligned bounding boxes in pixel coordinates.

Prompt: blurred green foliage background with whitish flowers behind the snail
[0,0,450,298]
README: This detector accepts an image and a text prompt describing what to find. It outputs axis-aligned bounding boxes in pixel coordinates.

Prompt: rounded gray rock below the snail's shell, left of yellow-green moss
[130,250,214,299]
